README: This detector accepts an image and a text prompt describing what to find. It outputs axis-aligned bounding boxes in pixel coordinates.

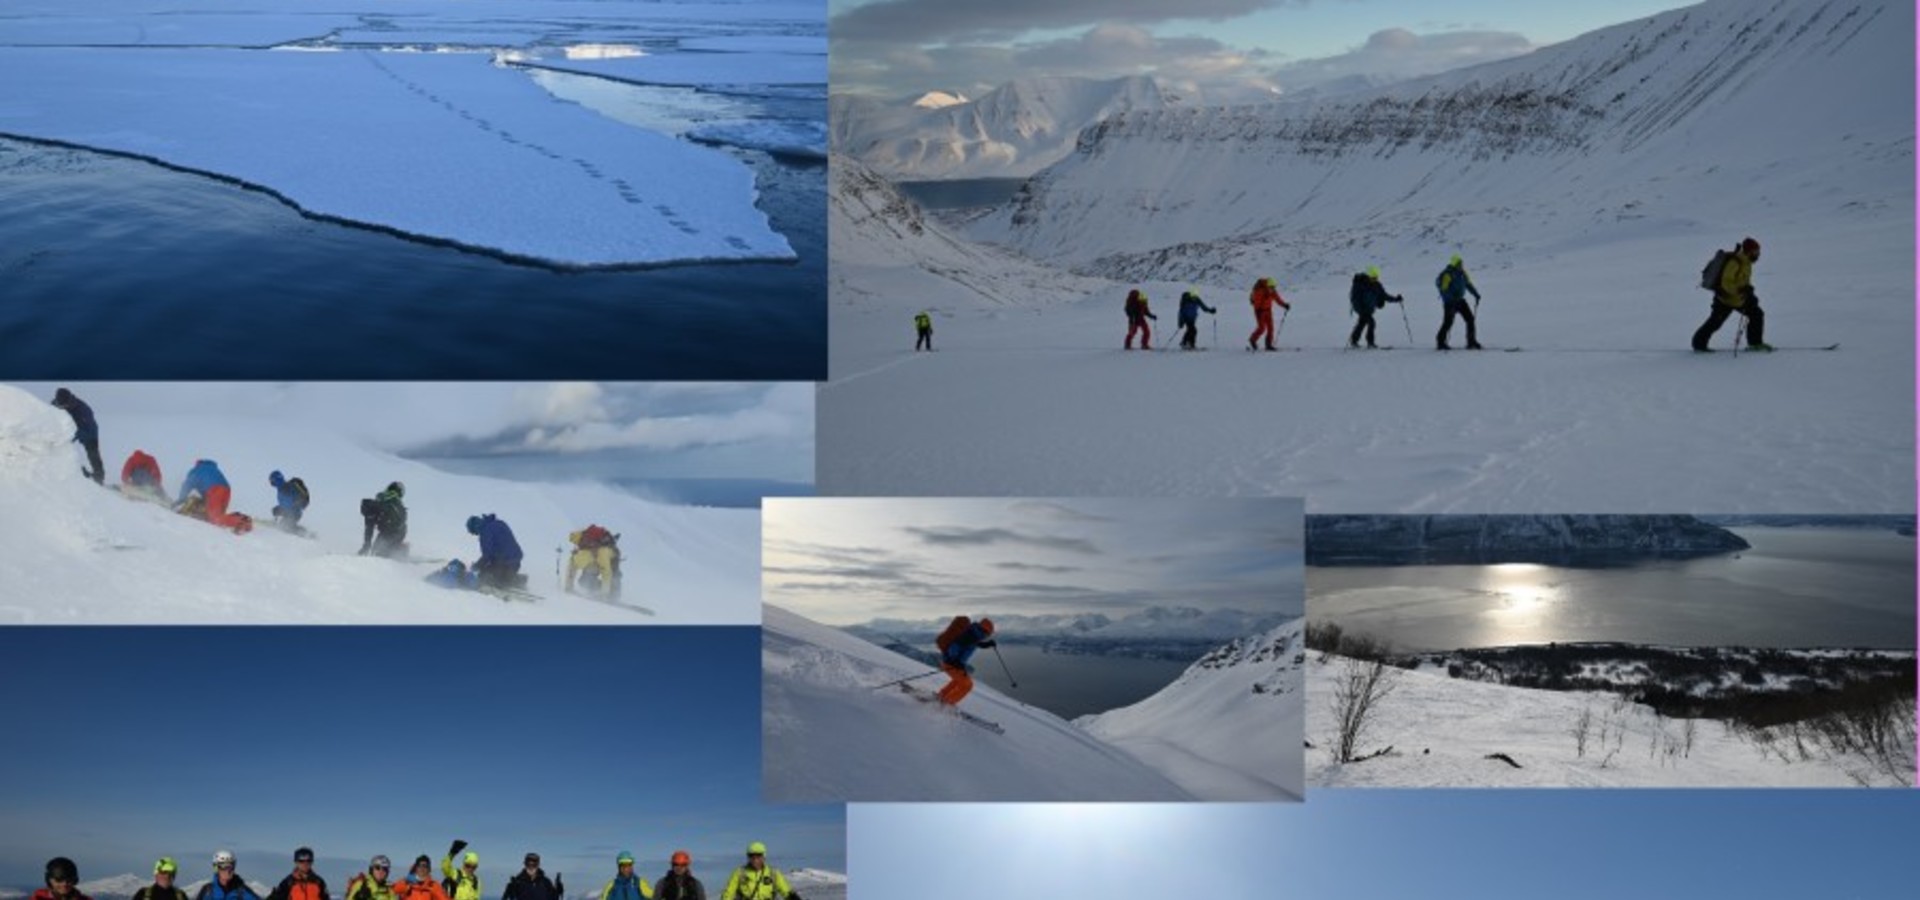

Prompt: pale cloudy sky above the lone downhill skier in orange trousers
[760,497,1306,626]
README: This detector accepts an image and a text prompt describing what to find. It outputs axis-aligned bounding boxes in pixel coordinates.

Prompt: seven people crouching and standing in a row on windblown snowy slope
[54,388,620,599]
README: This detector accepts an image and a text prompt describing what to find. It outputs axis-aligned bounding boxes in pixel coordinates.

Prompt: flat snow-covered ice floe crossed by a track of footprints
[0,48,795,267]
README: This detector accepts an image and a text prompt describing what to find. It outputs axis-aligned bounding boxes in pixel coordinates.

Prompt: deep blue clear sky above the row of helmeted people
[0,628,845,896]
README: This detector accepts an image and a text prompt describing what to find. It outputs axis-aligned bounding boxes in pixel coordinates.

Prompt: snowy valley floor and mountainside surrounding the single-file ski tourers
[818,0,1914,514]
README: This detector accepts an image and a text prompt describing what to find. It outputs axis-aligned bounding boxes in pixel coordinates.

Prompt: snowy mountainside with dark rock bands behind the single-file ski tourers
[979,0,1912,264]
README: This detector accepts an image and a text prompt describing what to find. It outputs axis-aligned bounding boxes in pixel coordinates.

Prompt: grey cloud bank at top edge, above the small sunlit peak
[828,0,1304,44]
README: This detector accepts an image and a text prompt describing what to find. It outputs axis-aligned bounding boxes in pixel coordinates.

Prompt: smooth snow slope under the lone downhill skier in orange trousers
[760,604,1192,802]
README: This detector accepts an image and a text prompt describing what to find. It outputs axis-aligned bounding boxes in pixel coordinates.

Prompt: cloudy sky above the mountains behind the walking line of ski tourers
[828,0,1686,98]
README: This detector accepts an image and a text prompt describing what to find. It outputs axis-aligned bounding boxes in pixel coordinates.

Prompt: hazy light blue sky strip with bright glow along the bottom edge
[847,791,1920,900]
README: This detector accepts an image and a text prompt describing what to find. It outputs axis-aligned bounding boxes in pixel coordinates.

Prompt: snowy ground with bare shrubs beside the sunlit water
[1306,651,1912,787]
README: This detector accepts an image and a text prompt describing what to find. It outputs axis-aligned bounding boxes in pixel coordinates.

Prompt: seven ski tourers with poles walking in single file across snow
[914,238,1774,353]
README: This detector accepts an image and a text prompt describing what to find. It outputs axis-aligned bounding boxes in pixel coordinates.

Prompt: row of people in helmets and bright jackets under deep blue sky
[33,841,801,900]
